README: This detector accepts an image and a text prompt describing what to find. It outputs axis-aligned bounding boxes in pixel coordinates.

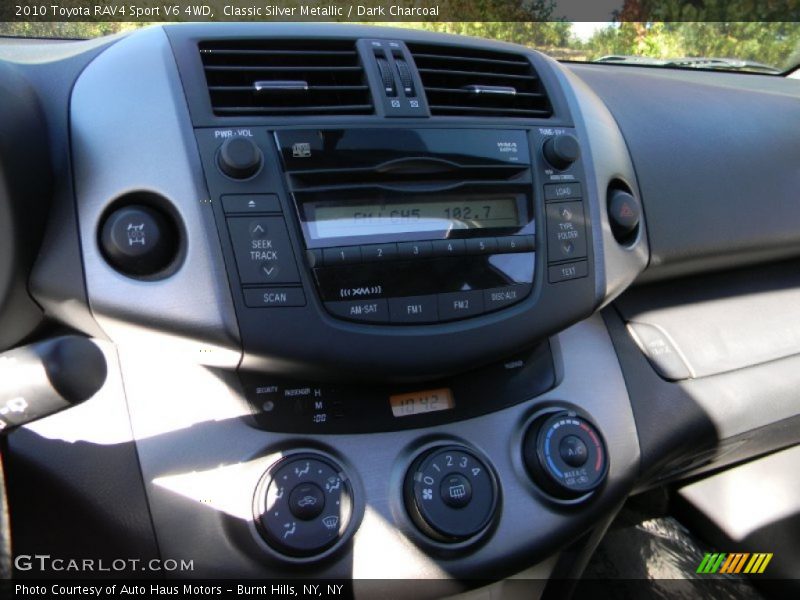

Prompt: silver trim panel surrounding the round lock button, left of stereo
[71,27,241,367]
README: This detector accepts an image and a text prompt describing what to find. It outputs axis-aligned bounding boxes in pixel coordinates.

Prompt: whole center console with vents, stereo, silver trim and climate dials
[37,24,645,579]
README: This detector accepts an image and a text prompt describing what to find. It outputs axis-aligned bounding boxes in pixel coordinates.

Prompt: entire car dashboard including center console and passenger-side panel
[0,24,800,593]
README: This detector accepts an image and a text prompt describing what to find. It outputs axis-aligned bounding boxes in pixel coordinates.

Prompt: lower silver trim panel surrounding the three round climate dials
[120,317,639,579]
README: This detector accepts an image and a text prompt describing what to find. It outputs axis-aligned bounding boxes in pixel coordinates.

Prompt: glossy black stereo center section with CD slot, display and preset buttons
[275,129,535,325]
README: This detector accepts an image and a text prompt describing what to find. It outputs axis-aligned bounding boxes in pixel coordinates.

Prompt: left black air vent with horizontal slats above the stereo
[200,40,372,116]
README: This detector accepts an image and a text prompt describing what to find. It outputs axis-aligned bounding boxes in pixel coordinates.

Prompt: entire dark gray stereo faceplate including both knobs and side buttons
[190,120,597,381]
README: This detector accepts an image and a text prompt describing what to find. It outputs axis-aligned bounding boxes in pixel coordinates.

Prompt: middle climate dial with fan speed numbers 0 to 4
[405,446,498,543]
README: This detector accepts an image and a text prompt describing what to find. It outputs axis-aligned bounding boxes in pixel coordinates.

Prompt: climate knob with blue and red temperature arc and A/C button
[522,411,608,499]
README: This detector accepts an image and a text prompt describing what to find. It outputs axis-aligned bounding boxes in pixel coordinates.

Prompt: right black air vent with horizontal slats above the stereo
[409,44,553,118]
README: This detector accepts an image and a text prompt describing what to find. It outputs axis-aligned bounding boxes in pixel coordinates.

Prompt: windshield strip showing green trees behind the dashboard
[0,21,800,73]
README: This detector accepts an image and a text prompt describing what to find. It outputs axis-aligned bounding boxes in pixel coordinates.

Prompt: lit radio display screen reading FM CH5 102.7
[305,195,526,240]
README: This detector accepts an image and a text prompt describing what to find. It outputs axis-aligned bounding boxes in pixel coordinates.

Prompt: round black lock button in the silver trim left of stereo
[100,205,178,276]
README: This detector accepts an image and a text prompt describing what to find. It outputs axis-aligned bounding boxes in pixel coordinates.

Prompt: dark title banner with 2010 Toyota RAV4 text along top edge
[0,0,800,22]
